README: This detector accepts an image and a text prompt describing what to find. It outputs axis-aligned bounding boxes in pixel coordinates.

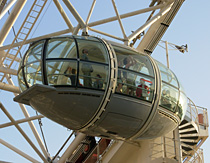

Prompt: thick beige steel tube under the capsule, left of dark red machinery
[59,133,86,163]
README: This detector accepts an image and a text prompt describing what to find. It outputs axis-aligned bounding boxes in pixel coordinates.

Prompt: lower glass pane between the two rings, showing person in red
[116,68,154,101]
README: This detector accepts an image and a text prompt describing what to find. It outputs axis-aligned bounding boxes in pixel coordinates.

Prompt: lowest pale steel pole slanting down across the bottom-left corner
[0,139,39,163]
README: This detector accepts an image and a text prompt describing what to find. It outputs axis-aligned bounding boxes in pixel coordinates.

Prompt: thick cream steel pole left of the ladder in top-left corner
[0,0,27,46]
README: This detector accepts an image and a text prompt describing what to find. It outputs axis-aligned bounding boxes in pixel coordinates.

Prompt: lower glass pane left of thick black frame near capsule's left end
[24,62,43,87]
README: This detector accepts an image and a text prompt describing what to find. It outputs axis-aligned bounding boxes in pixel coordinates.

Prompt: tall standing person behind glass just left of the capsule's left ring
[81,49,93,87]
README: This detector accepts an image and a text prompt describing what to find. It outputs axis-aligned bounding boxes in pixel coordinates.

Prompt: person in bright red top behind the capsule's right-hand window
[136,78,150,100]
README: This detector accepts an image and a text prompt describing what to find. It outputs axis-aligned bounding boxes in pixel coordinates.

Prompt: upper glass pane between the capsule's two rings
[113,46,154,76]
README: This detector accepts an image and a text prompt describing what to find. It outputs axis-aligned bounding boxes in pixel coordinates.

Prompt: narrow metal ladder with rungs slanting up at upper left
[0,0,47,82]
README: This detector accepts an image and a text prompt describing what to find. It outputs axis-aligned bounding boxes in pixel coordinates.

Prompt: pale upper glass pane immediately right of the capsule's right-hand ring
[156,61,178,88]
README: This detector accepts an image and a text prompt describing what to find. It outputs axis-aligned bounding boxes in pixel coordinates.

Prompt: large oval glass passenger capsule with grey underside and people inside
[15,36,187,141]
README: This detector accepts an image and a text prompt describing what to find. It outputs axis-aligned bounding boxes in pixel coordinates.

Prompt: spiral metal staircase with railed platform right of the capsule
[179,99,208,162]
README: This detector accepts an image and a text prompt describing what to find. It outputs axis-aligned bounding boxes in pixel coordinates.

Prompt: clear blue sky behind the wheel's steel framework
[0,0,210,162]
